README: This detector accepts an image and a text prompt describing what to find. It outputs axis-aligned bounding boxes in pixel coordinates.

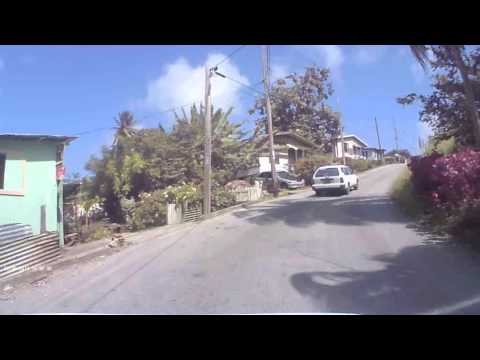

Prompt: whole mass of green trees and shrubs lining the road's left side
[66,66,340,240]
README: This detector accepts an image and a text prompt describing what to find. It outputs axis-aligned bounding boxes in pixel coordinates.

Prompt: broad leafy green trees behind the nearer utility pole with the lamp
[86,106,256,222]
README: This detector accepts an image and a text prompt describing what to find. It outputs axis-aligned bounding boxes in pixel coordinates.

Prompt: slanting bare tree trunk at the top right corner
[448,45,480,147]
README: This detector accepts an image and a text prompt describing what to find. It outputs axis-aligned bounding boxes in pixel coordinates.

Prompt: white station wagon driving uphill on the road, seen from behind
[312,165,360,195]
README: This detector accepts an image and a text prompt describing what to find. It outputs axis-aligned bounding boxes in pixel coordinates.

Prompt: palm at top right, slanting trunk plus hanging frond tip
[410,45,480,147]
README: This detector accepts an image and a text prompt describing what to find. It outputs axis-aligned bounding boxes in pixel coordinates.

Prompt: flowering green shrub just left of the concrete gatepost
[129,190,167,230]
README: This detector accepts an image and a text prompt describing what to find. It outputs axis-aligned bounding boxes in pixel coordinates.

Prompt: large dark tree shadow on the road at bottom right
[290,242,480,314]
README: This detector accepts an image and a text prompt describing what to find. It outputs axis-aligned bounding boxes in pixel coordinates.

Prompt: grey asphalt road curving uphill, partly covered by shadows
[0,165,480,314]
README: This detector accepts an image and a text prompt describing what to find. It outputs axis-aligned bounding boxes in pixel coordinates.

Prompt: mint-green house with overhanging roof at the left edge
[0,134,76,244]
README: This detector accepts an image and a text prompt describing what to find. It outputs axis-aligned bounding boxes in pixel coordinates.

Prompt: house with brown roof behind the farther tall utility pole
[238,131,320,178]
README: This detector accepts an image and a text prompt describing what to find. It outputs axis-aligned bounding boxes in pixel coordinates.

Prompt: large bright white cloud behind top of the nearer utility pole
[141,53,250,116]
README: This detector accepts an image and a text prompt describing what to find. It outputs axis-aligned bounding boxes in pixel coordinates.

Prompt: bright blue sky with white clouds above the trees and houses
[0,45,430,173]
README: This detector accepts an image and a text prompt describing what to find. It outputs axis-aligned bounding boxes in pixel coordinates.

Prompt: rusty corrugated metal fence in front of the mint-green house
[0,224,60,279]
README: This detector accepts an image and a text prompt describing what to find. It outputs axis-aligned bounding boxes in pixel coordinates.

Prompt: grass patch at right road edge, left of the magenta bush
[390,169,425,218]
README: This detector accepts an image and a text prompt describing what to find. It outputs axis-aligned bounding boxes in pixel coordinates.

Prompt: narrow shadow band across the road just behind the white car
[234,195,409,227]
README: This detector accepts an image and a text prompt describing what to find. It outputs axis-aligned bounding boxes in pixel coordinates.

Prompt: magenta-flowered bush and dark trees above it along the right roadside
[391,45,480,243]
